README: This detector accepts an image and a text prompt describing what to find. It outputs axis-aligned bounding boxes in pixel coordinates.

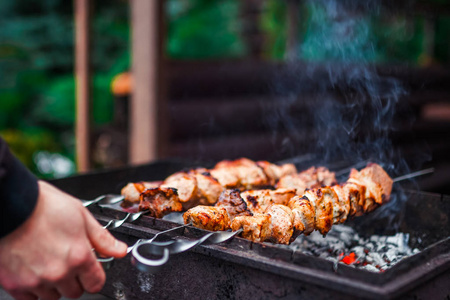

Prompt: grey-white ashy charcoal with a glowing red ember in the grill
[289,225,419,272]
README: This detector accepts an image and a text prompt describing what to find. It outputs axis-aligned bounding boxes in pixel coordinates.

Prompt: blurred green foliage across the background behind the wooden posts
[0,0,450,177]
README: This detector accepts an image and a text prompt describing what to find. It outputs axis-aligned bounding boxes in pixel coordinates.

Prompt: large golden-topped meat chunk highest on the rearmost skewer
[210,158,269,189]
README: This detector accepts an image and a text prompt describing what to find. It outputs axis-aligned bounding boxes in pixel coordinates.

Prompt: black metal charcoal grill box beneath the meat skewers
[52,160,450,299]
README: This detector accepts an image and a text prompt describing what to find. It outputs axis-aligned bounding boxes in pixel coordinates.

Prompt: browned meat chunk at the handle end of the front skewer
[183,205,231,231]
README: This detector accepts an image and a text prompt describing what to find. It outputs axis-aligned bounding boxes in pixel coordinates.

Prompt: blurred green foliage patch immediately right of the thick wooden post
[166,0,246,59]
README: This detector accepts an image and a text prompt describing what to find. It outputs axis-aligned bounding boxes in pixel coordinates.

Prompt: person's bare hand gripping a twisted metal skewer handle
[0,181,127,300]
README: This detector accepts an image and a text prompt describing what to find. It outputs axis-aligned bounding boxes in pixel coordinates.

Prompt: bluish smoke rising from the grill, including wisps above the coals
[272,0,429,227]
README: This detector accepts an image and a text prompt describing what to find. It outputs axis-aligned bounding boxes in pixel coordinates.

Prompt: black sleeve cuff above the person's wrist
[0,137,39,238]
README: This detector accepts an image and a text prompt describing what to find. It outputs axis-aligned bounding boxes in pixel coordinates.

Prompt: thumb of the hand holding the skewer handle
[85,210,128,258]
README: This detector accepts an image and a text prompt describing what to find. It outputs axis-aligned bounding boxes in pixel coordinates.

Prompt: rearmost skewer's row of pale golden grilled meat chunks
[122,158,297,215]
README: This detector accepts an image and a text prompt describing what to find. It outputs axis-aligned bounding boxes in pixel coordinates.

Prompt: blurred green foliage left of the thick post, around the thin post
[0,0,130,176]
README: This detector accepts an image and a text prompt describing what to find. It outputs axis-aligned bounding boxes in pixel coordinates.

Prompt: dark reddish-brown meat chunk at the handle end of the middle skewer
[139,187,183,218]
